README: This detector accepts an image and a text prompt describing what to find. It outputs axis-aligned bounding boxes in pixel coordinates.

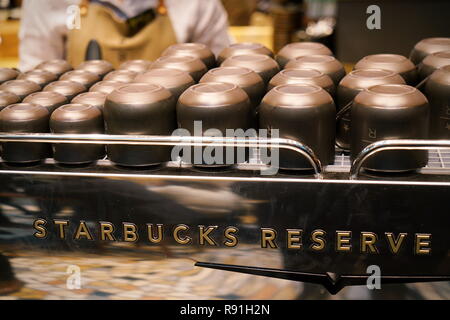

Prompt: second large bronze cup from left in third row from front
[221,54,280,85]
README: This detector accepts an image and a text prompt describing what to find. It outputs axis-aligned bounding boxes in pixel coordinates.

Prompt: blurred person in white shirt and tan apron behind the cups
[19,0,231,71]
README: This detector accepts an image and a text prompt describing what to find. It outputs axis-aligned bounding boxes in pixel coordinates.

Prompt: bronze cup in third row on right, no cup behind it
[354,54,419,86]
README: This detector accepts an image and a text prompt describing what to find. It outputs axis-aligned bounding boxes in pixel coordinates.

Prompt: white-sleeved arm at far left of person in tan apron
[19,0,70,71]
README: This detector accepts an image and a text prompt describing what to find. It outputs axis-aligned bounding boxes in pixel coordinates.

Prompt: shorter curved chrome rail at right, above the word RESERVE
[350,139,450,180]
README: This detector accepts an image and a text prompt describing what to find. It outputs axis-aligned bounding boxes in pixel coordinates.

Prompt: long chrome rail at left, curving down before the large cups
[0,133,322,179]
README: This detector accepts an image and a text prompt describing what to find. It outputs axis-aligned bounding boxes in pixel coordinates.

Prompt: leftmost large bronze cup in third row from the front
[150,56,208,82]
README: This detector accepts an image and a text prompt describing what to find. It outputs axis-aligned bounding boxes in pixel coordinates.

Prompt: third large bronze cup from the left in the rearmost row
[275,42,333,69]
